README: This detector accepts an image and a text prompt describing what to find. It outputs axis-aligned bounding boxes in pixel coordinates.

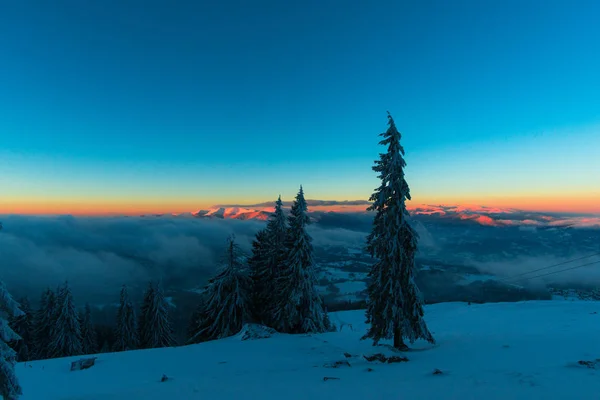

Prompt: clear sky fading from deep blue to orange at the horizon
[0,0,600,214]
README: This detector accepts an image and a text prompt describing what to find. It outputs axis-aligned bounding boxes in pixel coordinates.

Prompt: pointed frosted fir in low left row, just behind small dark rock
[49,282,83,357]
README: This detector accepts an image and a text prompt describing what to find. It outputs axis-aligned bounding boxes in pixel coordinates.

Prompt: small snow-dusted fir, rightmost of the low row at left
[139,282,175,349]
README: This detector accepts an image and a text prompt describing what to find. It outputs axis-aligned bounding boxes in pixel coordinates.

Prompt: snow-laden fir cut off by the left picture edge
[0,281,24,400]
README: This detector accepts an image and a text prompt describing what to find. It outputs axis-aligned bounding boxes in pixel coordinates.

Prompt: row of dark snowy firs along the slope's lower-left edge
[9,282,173,361]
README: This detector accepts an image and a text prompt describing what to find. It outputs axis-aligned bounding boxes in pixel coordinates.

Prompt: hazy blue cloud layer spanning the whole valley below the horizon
[0,206,600,301]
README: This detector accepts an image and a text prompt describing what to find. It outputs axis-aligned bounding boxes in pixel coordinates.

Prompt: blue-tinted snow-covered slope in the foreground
[17,301,600,400]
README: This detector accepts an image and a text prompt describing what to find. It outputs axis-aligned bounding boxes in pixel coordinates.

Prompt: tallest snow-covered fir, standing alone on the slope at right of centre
[364,113,434,349]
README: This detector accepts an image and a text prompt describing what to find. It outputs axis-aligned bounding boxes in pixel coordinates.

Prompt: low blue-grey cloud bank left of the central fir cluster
[0,216,263,304]
